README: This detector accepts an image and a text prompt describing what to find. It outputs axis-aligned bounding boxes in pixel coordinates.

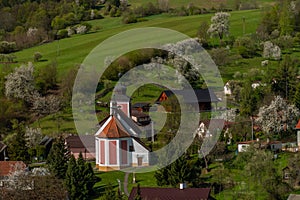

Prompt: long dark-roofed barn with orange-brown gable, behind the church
[156,89,220,111]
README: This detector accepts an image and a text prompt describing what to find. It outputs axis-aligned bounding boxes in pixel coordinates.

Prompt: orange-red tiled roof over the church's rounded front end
[97,115,130,138]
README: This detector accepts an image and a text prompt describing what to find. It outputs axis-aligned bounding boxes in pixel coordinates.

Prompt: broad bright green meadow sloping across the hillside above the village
[15,10,261,77]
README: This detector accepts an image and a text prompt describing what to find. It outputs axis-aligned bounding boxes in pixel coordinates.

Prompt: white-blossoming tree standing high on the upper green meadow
[207,12,230,40]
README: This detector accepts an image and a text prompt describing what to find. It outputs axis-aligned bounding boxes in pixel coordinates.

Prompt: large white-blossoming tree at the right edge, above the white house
[256,96,300,133]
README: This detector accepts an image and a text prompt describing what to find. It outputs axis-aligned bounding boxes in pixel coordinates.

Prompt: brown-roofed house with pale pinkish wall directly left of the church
[65,135,95,160]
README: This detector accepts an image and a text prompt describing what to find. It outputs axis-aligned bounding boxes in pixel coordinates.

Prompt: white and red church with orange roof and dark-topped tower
[95,86,150,171]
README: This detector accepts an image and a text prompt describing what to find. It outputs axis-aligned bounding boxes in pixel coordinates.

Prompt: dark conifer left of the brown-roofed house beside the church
[47,138,68,179]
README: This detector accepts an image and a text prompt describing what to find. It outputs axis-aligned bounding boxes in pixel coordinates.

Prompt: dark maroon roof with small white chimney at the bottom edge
[128,187,213,200]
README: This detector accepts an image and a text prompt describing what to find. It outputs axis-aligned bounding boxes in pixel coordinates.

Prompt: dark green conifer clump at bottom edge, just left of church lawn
[65,153,95,200]
